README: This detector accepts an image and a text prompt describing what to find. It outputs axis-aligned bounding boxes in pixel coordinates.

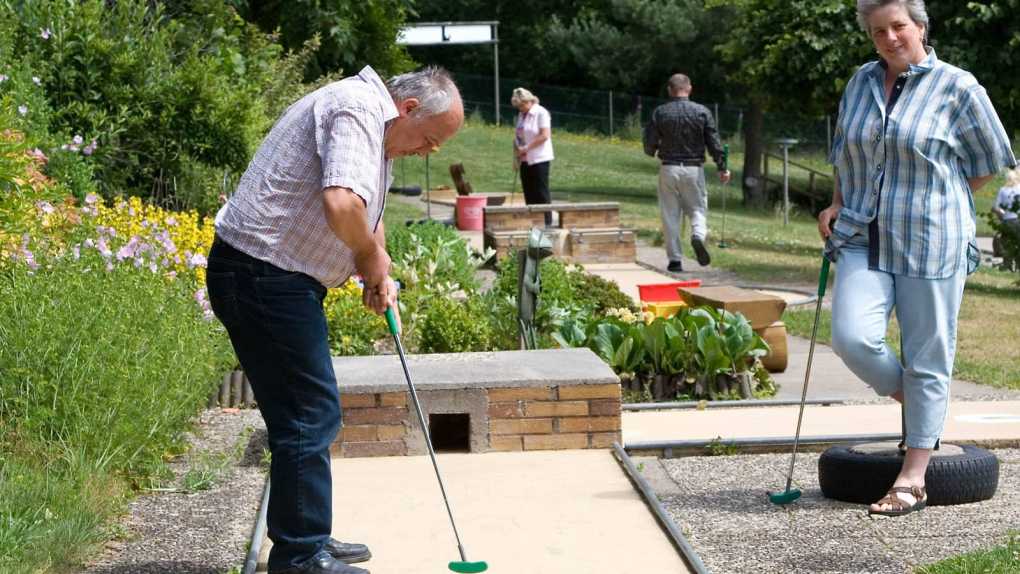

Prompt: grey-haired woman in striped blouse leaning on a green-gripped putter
[818,0,1016,516]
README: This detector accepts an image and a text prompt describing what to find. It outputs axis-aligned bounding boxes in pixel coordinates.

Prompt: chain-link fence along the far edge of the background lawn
[454,73,835,152]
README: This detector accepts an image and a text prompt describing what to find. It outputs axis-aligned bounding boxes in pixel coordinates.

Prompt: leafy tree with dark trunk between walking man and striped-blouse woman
[706,0,871,205]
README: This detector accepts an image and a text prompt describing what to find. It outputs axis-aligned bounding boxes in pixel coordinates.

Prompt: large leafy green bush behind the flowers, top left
[0,0,290,211]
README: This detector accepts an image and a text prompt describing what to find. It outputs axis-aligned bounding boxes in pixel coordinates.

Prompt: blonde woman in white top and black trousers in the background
[510,88,553,226]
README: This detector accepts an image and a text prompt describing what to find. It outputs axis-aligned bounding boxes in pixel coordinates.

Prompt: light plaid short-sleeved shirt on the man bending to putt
[216,66,398,286]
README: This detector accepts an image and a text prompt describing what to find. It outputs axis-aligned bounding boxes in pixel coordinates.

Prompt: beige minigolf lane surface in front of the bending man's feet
[259,451,689,574]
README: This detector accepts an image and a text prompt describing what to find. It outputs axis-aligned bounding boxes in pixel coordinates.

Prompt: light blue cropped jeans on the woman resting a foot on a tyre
[832,238,967,449]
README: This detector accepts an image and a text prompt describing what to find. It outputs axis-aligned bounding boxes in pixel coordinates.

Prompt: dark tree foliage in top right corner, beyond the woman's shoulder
[928,0,1020,139]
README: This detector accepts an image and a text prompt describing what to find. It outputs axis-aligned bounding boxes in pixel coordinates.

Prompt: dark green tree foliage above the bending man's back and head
[232,0,414,82]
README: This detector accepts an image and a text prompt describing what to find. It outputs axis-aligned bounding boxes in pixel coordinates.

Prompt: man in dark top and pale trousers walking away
[645,73,729,272]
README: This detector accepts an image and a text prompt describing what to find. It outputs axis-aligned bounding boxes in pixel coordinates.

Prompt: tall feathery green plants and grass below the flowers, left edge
[0,250,234,572]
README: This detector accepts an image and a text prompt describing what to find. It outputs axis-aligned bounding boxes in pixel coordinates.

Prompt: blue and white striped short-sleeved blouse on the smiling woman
[825,48,1016,279]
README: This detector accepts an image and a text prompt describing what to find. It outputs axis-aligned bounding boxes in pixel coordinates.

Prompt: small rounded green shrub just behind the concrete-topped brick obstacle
[419,298,491,353]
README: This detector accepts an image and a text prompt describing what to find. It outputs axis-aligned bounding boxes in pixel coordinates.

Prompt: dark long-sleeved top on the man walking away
[645,98,726,171]
